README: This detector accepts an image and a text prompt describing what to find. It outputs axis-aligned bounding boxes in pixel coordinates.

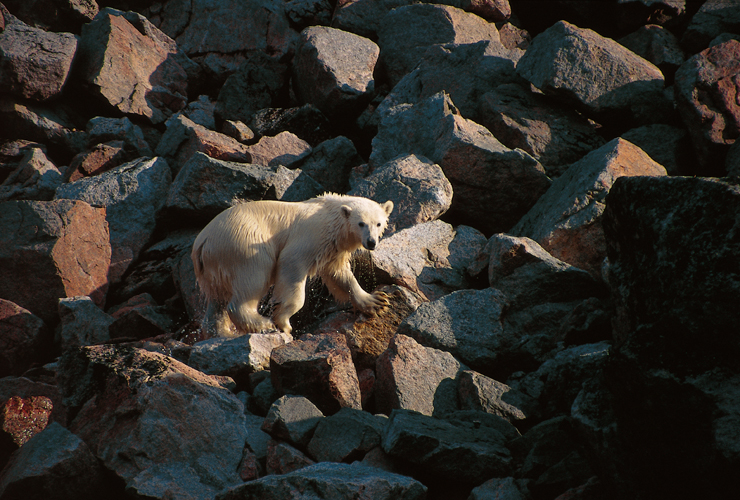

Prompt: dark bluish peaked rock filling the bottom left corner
[0,422,105,500]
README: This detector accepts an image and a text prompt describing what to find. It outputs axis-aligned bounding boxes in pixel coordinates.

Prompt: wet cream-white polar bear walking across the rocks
[191,193,393,336]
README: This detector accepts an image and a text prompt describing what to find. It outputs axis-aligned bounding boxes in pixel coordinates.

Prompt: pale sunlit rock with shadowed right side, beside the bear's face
[371,220,485,300]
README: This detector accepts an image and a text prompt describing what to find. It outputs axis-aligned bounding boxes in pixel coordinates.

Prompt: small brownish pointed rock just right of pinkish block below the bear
[458,370,527,422]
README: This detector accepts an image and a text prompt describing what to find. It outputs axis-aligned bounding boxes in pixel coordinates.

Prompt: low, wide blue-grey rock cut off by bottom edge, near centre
[216,463,427,500]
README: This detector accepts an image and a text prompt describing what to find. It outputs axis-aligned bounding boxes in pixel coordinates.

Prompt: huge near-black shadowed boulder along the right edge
[602,177,740,498]
